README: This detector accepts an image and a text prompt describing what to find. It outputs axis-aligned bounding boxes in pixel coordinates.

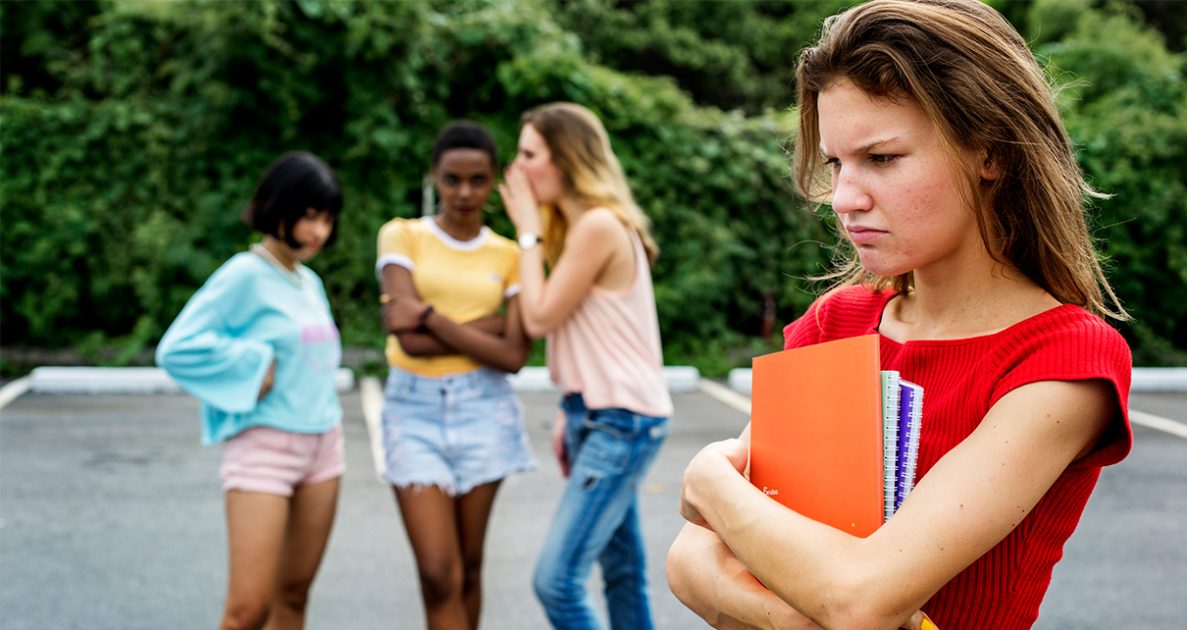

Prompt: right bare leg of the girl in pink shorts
[268,478,339,630]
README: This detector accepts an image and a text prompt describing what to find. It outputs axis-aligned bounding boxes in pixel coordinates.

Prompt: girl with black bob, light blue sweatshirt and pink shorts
[157,153,345,629]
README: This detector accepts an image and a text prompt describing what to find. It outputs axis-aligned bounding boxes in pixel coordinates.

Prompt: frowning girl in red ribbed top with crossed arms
[667,0,1131,629]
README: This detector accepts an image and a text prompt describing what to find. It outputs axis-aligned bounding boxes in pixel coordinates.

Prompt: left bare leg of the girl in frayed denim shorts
[395,486,469,630]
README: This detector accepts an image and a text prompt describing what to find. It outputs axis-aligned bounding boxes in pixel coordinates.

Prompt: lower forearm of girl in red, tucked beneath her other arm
[667,524,819,629]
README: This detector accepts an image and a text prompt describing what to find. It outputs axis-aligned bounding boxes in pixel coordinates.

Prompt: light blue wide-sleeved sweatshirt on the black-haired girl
[157,252,342,444]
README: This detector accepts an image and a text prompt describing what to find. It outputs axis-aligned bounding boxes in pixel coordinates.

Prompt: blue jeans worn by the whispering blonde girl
[533,394,668,630]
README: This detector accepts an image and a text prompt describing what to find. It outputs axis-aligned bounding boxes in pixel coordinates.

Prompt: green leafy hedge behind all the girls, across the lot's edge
[0,0,1187,374]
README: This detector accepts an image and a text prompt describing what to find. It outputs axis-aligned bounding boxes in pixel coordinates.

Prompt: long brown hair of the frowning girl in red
[794,0,1129,320]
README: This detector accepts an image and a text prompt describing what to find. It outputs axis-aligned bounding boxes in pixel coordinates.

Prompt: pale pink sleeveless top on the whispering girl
[548,224,672,418]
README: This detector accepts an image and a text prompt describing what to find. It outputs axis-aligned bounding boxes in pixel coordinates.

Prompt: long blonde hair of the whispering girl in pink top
[520,103,660,265]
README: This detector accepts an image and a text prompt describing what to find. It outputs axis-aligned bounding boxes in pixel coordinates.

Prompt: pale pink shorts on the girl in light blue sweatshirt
[218,425,347,497]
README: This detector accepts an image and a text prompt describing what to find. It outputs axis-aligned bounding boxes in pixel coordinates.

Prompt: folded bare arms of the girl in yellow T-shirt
[382,265,531,373]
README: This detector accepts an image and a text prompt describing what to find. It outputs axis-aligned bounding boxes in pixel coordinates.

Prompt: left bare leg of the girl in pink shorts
[218,490,288,630]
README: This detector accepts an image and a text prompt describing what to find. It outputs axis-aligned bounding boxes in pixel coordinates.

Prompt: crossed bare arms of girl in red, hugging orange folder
[667,381,1117,628]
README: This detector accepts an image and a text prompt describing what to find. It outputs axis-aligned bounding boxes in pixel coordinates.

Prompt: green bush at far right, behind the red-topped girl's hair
[1034,2,1187,364]
